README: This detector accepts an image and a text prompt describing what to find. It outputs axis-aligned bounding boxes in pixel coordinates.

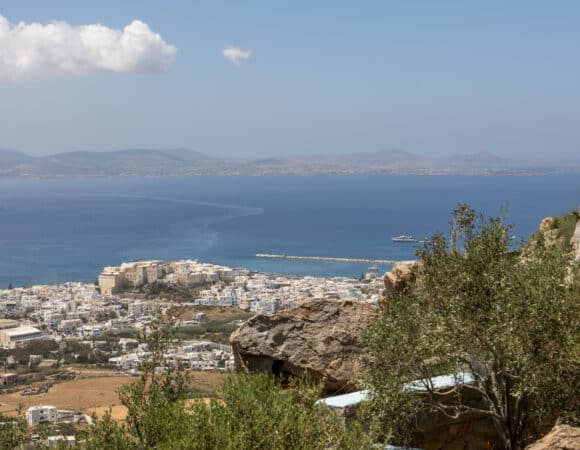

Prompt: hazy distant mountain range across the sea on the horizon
[0,149,580,178]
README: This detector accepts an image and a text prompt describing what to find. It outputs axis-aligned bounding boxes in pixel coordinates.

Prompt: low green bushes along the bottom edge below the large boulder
[87,312,368,450]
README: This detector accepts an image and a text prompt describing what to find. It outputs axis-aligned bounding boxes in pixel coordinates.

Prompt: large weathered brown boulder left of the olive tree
[230,299,375,392]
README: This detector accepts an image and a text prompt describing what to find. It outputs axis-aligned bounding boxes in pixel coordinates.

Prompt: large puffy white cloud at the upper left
[0,15,177,80]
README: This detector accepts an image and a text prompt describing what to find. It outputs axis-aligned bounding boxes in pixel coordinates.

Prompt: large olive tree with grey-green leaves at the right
[363,207,580,450]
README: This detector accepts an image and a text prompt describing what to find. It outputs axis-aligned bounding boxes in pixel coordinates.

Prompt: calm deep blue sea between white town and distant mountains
[0,175,580,287]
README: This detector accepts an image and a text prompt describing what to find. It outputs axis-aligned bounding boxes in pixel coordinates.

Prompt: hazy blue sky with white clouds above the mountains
[0,0,580,159]
